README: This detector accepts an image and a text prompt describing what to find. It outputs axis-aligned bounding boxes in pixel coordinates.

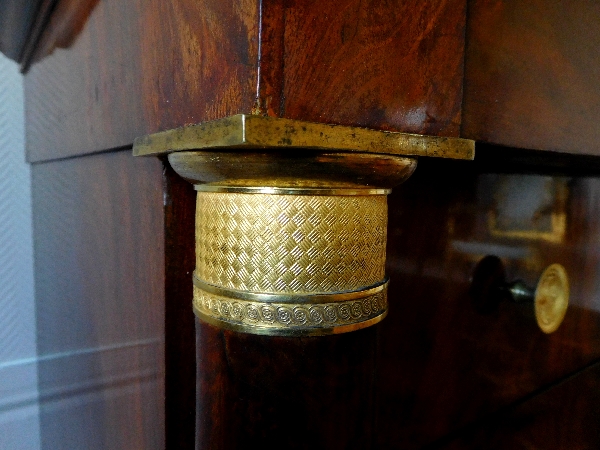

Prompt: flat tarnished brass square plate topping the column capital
[133,114,475,159]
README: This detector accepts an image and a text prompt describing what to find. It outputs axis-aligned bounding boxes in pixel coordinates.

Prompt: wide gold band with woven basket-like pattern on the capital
[196,192,387,294]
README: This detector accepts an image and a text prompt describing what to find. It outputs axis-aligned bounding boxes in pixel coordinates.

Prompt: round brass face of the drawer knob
[534,264,569,333]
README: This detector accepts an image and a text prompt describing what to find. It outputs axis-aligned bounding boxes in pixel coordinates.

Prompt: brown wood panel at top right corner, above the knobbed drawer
[462,0,600,155]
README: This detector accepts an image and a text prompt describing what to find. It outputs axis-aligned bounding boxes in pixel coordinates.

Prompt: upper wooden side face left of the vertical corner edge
[25,0,258,161]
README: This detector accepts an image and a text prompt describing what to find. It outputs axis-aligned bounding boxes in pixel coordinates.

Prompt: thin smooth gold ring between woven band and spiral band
[193,274,388,304]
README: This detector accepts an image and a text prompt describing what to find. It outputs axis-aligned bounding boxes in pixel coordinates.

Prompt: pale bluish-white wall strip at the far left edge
[0,53,40,450]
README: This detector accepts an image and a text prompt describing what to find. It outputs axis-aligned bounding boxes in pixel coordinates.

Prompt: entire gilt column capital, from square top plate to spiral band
[134,114,474,336]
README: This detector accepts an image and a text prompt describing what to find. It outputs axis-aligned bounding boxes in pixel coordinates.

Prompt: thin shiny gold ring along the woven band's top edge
[194,184,392,196]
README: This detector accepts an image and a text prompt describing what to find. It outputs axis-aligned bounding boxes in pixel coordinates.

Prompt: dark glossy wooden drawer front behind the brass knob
[376,160,600,449]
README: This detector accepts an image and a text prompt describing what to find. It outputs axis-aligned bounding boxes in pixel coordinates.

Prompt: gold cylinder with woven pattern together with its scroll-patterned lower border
[194,186,387,335]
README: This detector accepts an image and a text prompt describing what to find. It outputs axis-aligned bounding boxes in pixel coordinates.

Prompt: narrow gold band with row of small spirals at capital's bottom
[194,284,387,336]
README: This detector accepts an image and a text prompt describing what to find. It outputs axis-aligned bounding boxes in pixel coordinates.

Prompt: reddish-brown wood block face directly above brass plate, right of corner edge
[259,0,466,136]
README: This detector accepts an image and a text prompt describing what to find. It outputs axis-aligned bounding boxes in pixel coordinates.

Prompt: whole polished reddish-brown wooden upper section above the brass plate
[26,0,600,160]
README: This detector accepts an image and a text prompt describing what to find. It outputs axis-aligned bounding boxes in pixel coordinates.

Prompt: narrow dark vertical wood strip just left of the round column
[163,160,196,450]
